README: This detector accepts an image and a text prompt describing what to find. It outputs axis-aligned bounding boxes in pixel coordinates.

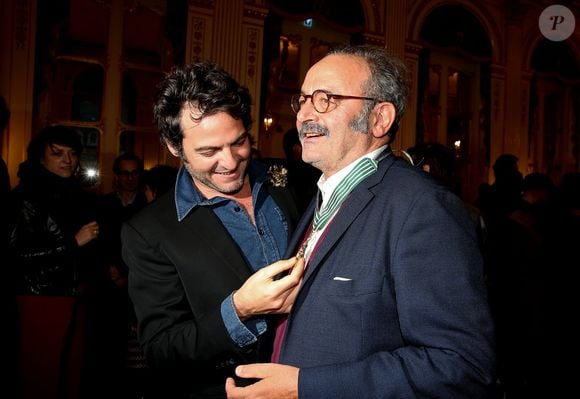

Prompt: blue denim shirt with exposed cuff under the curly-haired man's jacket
[175,162,288,347]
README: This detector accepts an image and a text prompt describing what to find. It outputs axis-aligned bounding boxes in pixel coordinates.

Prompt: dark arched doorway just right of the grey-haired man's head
[416,5,492,201]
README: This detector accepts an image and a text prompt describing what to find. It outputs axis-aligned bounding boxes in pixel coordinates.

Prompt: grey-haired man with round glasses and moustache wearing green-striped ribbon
[226,46,494,399]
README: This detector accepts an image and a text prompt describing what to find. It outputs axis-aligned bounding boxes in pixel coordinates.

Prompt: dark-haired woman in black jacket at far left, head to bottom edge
[8,126,101,398]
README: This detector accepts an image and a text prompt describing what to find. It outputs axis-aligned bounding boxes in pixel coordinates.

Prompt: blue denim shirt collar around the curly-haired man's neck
[175,161,267,222]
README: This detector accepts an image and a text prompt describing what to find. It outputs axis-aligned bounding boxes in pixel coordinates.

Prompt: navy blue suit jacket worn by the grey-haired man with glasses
[280,156,494,399]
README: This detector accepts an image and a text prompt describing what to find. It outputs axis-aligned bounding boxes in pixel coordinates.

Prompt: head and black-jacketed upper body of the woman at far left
[9,126,99,295]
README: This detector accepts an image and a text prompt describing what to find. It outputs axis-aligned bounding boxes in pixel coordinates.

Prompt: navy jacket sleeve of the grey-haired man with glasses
[299,190,494,399]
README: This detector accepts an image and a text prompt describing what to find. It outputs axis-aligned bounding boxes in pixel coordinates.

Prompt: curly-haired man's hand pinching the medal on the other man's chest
[233,257,304,320]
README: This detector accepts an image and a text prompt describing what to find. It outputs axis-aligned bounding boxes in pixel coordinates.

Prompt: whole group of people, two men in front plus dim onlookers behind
[0,46,580,399]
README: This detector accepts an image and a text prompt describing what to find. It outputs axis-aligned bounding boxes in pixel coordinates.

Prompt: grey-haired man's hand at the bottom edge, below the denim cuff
[226,363,300,399]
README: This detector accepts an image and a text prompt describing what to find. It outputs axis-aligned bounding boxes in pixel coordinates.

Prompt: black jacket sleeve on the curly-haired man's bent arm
[122,222,239,368]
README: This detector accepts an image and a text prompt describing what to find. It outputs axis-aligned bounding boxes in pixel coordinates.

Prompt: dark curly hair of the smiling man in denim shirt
[153,62,252,154]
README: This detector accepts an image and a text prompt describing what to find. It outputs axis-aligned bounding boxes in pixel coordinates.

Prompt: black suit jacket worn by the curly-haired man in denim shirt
[122,186,298,397]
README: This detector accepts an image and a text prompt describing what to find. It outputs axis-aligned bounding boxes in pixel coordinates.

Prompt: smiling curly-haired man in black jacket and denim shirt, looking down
[122,63,303,398]
